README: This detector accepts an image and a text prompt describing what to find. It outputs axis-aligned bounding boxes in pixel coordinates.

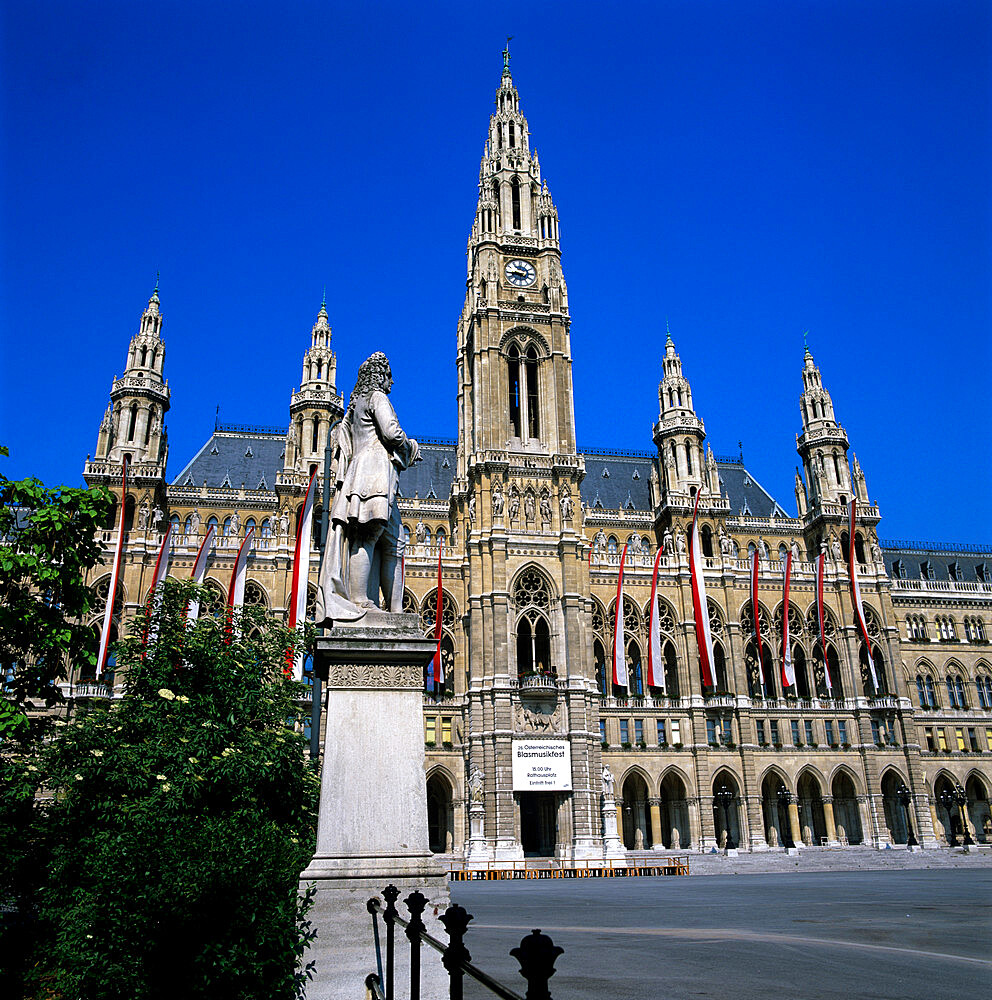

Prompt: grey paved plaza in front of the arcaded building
[451,852,992,1000]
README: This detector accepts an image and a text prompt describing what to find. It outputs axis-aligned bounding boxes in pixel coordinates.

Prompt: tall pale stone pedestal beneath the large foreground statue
[300,611,449,1000]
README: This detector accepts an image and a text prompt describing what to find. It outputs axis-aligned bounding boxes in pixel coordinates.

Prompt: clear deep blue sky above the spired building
[0,0,992,542]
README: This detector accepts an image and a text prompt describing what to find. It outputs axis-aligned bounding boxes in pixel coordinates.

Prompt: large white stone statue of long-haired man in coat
[316,351,420,624]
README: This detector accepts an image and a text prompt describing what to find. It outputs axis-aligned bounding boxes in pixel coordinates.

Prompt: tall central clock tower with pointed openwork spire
[451,51,603,861]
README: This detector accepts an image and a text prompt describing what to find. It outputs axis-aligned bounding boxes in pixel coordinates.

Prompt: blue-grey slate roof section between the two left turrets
[172,429,286,490]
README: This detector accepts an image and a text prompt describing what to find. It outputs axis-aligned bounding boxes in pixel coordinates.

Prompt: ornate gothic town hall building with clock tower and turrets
[79,60,992,861]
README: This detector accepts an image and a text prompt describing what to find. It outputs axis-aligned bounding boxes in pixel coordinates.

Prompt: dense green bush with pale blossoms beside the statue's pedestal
[27,580,319,1000]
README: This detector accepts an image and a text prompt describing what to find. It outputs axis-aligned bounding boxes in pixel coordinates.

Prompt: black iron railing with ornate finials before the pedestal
[365,885,565,1000]
